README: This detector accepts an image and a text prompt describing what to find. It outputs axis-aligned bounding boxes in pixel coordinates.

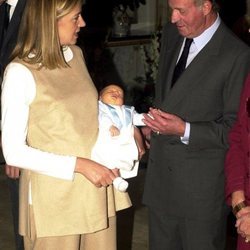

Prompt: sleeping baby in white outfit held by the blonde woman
[92,84,145,192]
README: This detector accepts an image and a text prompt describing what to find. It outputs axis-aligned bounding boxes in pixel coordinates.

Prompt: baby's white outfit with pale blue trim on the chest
[91,101,145,191]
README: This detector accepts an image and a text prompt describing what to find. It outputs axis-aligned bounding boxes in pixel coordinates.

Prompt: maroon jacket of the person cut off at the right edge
[225,74,250,205]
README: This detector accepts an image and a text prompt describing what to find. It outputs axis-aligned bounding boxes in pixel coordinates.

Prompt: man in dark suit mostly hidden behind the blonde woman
[0,0,26,250]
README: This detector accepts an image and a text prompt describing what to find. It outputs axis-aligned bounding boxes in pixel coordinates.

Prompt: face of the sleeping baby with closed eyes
[100,85,124,106]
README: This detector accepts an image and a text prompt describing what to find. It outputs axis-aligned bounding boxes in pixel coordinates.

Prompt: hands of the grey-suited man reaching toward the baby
[143,108,186,136]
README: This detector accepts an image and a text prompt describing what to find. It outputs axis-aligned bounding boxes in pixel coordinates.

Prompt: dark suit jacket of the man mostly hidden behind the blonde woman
[0,0,26,76]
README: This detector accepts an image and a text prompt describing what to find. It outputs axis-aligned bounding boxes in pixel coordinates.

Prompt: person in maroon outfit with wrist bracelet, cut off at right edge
[225,74,250,250]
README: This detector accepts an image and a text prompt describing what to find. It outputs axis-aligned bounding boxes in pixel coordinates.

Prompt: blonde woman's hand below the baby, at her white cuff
[75,158,119,187]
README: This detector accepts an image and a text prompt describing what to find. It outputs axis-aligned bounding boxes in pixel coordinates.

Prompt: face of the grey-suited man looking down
[168,0,206,38]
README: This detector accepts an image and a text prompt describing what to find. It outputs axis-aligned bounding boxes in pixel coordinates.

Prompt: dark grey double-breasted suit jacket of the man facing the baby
[143,24,250,219]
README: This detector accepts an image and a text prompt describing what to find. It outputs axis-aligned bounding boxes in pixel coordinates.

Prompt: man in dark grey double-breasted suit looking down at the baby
[143,0,250,250]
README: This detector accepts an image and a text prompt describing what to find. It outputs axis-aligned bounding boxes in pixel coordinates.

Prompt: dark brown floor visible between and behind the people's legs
[0,167,236,250]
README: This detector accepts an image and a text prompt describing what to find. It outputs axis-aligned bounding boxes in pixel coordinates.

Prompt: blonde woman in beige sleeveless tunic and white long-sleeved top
[2,0,131,250]
